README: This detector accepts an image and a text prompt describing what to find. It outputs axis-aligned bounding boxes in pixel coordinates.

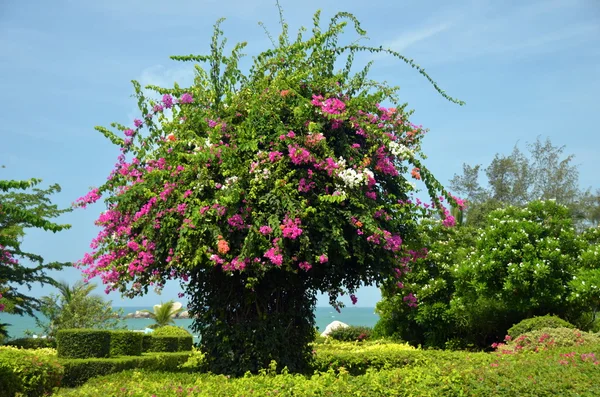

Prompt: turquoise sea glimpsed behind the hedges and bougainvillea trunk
[0,306,379,339]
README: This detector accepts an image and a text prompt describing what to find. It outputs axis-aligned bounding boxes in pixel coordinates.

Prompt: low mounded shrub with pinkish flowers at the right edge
[492,327,600,354]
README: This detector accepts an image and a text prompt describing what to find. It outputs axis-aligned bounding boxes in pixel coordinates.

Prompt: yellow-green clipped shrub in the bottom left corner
[0,346,63,397]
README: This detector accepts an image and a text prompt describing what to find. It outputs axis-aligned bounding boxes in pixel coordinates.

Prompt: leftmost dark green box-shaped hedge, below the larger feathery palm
[56,329,111,358]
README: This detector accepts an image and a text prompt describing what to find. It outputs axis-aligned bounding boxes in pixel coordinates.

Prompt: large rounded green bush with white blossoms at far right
[451,201,582,346]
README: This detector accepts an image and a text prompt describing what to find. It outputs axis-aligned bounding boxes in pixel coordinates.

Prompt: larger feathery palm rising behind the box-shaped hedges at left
[36,281,124,336]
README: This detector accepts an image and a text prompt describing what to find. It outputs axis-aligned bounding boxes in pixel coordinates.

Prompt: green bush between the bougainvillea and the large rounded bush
[375,220,476,348]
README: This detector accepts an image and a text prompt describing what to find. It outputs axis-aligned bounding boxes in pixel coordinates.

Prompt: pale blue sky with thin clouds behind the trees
[0,0,600,306]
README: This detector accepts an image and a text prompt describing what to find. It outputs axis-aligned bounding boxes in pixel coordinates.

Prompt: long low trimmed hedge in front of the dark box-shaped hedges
[60,353,190,387]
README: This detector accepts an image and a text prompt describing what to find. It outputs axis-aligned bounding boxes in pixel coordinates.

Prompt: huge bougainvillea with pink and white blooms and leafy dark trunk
[78,9,458,374]
